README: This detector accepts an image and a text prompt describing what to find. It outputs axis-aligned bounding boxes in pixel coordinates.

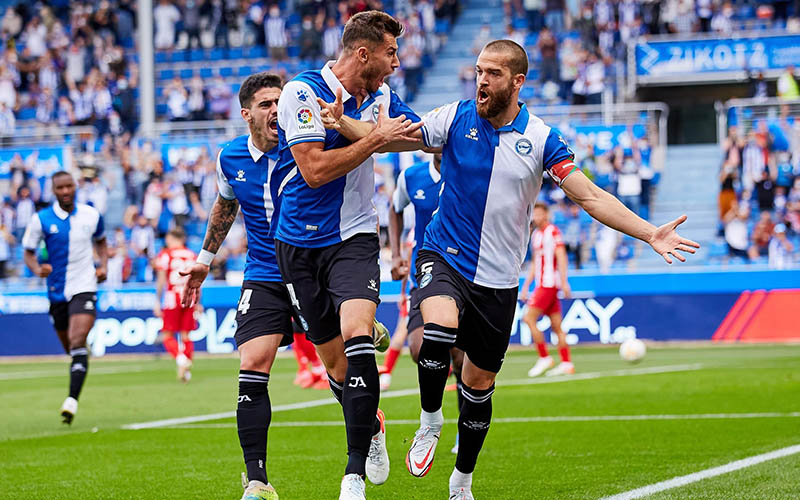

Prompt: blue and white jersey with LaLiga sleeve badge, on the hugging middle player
[275,62,419,248]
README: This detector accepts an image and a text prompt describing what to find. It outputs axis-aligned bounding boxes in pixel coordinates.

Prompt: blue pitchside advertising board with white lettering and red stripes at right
[0,270,800,356]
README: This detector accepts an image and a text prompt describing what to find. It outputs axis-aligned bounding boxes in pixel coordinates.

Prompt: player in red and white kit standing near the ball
[522,203,575,377]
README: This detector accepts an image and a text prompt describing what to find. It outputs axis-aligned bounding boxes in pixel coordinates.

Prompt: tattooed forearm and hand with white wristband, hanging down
[180,195,239,307]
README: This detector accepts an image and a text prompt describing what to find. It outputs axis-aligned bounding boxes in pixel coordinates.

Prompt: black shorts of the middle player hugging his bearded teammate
[275,234,381,345]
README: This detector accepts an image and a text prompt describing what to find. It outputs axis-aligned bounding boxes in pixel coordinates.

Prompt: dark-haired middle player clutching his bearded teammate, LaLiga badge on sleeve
[275,11,420,500]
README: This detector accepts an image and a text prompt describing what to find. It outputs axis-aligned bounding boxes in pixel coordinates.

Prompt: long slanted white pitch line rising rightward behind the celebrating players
[121,363,703,431]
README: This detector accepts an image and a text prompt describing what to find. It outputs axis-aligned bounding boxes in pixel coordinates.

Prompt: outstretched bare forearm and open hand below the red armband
[561,171,700,264]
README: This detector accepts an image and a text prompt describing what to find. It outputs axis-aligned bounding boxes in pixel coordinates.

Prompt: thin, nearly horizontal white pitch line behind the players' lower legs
[159,412,800,429]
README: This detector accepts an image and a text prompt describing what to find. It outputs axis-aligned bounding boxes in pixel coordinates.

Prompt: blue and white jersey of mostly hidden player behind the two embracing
[392,160,442,286]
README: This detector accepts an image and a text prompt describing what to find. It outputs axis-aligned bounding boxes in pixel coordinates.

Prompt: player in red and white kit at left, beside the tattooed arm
[153,228,202,382]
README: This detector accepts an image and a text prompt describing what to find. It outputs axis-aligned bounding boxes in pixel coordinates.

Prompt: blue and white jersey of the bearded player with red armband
[422,100,575,288]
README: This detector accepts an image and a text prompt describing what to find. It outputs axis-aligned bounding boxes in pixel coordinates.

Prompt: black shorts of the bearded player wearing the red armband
[409,250,518,373]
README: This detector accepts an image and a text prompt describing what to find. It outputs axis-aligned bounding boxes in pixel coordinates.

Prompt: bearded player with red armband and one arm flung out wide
[322,40,699,500]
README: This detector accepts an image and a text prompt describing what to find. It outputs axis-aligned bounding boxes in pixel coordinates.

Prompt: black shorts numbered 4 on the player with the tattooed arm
[238,281,294,347]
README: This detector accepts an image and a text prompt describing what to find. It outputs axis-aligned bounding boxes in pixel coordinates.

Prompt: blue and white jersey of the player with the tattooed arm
[217,135,284,281]
